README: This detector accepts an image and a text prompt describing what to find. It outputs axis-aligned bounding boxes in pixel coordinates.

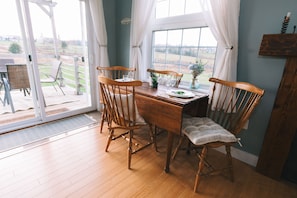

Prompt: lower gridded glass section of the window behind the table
[153,28,217,85]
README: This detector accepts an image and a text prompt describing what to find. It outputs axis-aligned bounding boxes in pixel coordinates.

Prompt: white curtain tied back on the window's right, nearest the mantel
[200,0,240,81]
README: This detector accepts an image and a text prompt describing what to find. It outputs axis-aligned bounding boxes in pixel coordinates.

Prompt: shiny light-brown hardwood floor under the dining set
[0,112,297,198]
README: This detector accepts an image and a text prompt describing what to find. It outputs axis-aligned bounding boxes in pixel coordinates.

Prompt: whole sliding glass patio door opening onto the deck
[0,0,95,132]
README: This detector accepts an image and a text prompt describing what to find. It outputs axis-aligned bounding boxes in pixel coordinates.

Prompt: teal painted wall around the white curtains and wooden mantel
[104,0,297,155]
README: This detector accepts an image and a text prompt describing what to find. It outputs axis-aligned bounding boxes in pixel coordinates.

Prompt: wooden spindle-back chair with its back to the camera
[98,75,156,169]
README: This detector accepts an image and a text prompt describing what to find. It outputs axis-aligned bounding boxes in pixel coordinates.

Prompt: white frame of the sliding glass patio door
[0,0,98,133]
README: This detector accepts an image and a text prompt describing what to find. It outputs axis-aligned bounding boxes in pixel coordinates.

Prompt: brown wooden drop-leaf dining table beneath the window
[135,82,208,173]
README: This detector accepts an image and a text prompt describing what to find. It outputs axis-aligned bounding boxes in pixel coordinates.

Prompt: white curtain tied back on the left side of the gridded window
[130,0,155,80]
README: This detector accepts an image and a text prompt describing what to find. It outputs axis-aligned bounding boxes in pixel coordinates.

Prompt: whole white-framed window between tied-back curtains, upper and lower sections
[152,0,217,85]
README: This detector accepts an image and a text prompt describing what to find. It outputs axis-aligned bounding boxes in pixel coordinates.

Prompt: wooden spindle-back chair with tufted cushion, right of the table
[173,78,264,192]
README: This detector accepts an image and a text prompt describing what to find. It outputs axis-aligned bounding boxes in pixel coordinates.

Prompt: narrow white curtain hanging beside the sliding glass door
[89,0,109,66]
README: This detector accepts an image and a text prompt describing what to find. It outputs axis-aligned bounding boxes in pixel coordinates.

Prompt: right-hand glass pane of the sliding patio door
[29,0,91,116]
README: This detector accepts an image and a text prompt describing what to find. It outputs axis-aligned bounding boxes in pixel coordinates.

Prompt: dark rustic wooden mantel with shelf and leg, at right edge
[257,34,297,179]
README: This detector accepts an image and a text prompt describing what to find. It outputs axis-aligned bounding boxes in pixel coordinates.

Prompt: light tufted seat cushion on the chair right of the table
[182,117,238,145]
